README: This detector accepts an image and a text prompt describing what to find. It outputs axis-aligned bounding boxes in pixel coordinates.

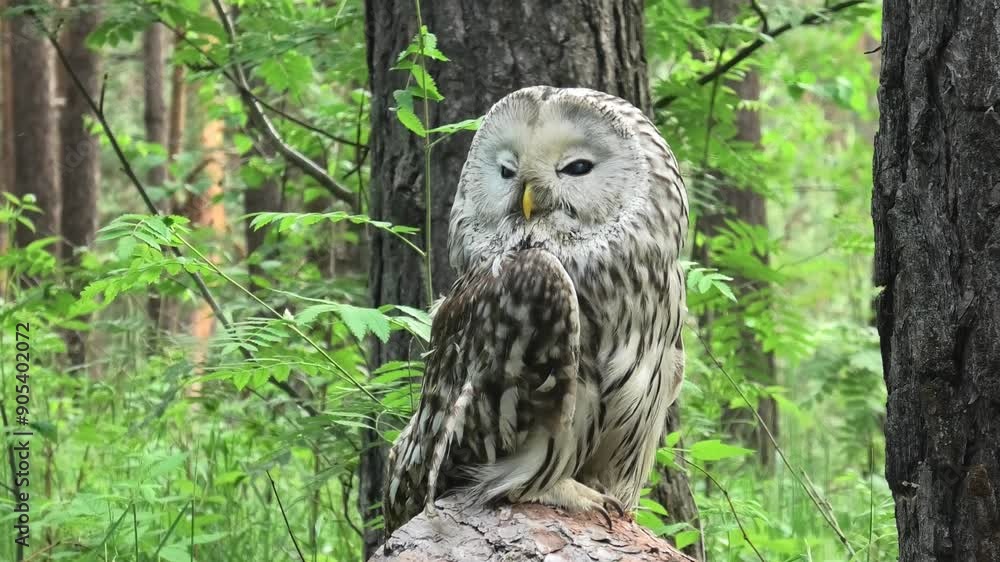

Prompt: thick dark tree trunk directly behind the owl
[359,0,693,555]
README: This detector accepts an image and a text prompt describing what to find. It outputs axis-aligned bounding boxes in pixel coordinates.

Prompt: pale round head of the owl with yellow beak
[450,86,673,270]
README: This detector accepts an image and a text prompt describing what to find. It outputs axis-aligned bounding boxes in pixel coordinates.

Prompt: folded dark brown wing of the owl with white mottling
[383,249,580,534]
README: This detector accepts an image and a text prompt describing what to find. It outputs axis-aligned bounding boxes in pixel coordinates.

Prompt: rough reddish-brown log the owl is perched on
[371,499,694,562]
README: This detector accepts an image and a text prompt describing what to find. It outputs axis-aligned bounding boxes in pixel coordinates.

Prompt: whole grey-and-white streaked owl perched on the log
[383,86,688,536]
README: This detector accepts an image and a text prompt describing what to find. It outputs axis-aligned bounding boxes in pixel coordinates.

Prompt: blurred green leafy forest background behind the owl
[0,0,897,561]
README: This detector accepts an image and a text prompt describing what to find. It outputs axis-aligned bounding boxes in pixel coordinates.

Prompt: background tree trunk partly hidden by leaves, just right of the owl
[691,0,778,466]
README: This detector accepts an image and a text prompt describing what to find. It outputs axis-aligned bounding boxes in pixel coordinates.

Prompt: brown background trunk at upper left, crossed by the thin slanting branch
[60,0,101,367]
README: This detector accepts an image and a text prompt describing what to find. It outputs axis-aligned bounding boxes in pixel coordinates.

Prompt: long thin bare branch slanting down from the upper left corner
[35,15,319,417]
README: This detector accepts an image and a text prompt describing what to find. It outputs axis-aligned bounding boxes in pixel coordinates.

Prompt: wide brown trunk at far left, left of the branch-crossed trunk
[11,0,61,249]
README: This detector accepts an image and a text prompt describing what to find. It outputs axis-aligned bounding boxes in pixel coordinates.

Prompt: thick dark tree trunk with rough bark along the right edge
[872,0,1000,562]
